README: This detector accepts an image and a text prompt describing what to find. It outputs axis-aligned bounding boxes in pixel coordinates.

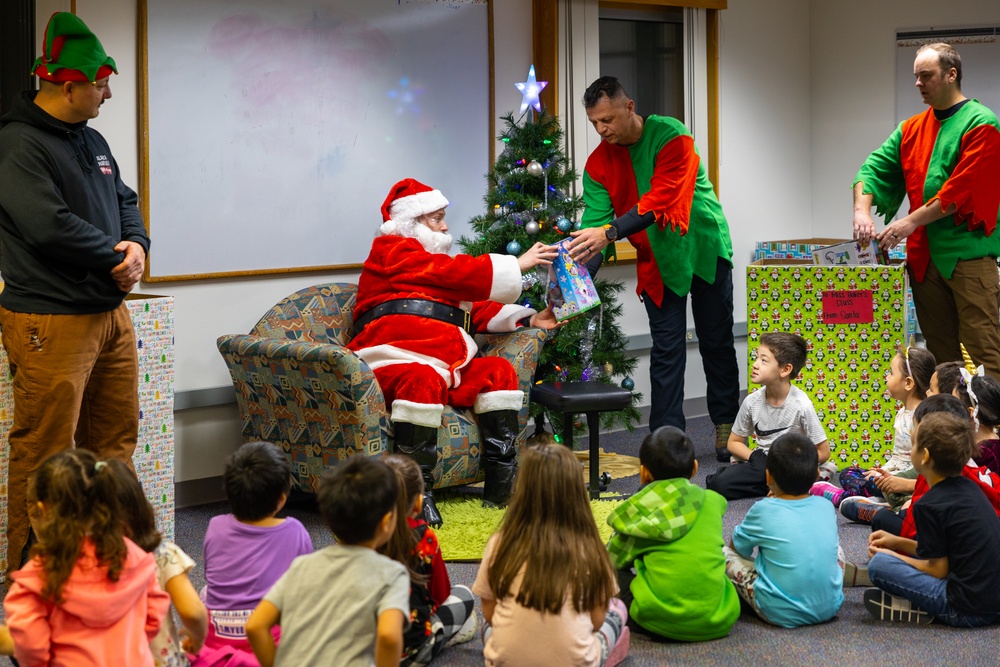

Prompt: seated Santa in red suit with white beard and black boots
[347,178,557,525]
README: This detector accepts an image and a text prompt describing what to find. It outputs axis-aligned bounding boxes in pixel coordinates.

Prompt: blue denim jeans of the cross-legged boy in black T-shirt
[868,553,1000,628]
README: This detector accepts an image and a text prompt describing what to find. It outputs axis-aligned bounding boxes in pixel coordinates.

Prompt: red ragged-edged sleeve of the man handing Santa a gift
[638,135,700,235]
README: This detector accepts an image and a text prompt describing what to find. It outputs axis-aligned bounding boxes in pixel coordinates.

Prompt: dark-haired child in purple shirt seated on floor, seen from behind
[192,442,312,667]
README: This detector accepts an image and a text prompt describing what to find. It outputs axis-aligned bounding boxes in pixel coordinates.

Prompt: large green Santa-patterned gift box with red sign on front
[747,259,912,468]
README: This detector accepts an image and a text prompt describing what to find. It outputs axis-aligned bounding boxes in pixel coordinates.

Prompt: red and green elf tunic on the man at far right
[854,100,1000,282]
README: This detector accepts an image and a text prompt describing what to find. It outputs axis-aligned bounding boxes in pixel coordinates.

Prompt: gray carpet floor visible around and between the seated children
[162,418,1000,667]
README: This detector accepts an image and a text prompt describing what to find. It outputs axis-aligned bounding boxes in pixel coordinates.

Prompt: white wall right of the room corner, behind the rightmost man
[808,0,1000,236]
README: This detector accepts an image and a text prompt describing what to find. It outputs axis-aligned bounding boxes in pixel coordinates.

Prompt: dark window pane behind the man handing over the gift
[598,7,685,120]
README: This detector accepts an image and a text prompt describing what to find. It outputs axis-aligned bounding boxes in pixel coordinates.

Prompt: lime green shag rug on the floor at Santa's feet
[434,494,621,562]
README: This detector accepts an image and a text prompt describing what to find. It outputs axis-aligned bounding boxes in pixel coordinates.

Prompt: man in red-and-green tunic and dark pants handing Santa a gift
[571,76,740,461]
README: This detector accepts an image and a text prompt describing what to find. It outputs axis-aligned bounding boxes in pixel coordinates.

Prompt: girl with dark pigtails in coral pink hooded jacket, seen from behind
[4,449,170,667]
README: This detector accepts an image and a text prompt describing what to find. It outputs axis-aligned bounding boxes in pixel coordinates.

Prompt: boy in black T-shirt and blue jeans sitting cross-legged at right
[864,413,1000,627]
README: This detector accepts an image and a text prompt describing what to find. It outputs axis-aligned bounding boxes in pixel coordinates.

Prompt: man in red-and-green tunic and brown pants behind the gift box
[854,43,1000,377]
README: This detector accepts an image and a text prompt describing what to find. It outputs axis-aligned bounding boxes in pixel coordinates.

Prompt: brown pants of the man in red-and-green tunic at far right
[910,257,1000,379]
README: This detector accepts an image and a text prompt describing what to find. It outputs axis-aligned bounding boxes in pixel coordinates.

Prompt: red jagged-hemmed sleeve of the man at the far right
[936,125,1000,236]
